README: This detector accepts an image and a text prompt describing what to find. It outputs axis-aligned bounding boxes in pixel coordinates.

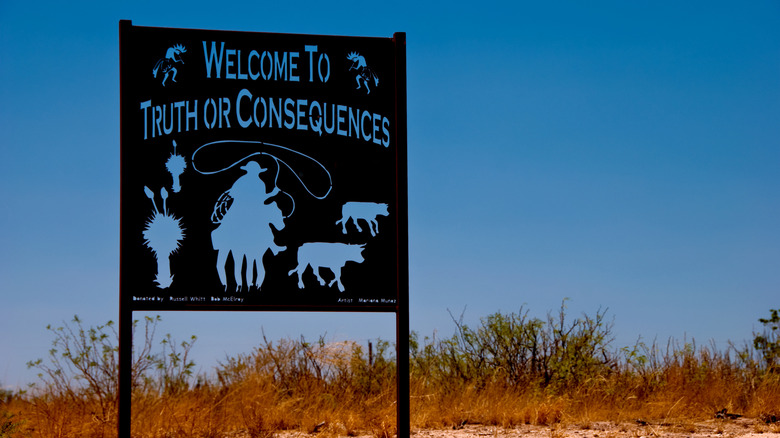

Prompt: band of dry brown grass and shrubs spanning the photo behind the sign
[0,307,780,438]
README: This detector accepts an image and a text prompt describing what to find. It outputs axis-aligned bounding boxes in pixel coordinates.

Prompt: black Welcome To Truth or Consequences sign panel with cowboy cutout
[120,25,406,311]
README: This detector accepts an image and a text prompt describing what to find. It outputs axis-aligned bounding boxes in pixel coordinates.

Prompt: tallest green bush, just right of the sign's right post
[409,304,614,392]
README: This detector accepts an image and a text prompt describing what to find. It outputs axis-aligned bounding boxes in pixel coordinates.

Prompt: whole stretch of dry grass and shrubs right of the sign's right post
[410,303,780,427]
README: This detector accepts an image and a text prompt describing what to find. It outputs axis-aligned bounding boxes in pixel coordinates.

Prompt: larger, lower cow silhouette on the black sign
[287,242,366,292]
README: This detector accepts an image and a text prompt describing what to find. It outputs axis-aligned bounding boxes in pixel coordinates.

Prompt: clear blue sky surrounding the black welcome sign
[0,0,780,386]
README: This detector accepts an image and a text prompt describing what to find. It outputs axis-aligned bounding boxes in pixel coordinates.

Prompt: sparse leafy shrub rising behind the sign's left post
[27,316,195,436]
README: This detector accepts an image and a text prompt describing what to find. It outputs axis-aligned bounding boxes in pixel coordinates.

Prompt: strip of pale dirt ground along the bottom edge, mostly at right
[276,418,780,438]
